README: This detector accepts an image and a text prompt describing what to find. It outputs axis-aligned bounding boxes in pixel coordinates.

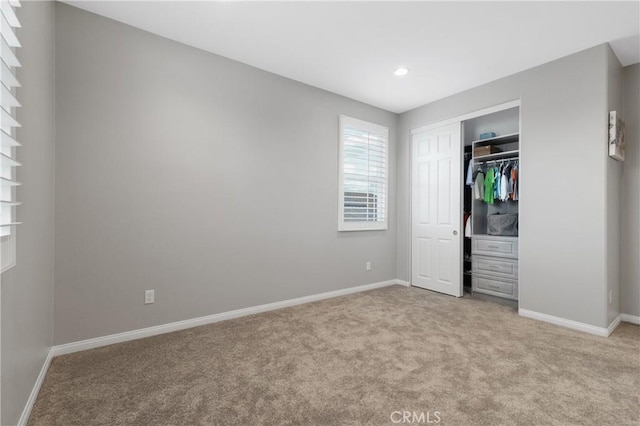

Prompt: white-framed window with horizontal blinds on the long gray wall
[338,115,389,231]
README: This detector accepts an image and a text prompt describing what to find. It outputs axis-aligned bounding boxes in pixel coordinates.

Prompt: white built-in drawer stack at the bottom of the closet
[471,235,518,300]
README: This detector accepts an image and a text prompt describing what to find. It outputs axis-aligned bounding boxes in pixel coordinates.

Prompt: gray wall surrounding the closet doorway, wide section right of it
[397,45,609,327]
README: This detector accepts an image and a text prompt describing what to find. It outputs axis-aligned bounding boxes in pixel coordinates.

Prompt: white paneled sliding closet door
[411,122,463,297]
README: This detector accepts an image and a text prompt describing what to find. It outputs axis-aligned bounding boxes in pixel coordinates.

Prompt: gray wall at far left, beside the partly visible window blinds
[1,1,54,425]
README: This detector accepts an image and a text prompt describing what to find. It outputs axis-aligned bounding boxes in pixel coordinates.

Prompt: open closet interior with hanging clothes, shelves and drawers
[461,106,520,308]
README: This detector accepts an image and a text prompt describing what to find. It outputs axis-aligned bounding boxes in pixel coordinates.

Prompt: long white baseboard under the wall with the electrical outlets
[51,279,404,356]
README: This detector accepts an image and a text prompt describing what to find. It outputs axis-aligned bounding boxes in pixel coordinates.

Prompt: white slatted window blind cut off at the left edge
[0,0,20,237]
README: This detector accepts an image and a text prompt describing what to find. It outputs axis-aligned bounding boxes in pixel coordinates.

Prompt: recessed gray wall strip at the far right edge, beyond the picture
[620,64,640,316]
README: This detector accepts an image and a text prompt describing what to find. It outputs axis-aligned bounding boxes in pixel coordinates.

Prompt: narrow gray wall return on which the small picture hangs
[602,45,622,324]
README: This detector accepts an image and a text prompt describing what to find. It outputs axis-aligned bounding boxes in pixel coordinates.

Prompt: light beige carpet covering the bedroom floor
[29,286,640,426]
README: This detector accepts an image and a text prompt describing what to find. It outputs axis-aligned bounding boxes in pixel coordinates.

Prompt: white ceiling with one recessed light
[65,1,640,113]
